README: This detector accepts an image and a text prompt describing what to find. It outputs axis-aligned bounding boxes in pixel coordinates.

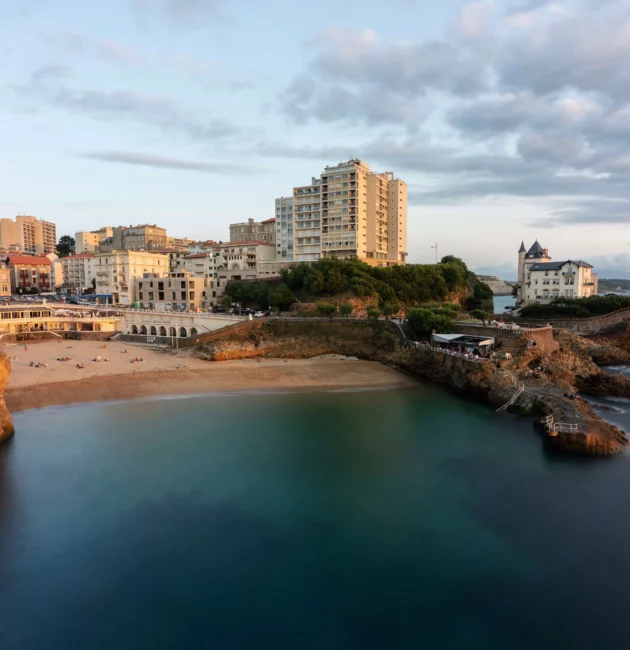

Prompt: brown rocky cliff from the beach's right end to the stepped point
[194,321,630,455]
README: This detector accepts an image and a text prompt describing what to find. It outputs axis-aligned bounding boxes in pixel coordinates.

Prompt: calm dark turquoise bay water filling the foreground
[0,386,630,650]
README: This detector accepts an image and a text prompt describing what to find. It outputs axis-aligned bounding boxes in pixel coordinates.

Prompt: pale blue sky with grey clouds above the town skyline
[0,0,630,279]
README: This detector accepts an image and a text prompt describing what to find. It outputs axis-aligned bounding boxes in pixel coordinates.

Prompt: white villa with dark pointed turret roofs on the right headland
[518,241,597,306]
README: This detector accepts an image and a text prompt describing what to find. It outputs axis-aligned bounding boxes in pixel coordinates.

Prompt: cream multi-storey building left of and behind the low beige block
[93,250,170,305]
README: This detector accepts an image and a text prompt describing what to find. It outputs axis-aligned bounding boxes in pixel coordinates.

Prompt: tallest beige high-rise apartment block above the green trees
[276,159,407,266]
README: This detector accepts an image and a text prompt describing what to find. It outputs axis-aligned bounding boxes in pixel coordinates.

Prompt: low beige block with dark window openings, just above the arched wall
[134,271,206,311]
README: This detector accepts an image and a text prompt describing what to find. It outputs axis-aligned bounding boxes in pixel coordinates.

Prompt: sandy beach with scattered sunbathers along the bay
[2,341,415,412]
